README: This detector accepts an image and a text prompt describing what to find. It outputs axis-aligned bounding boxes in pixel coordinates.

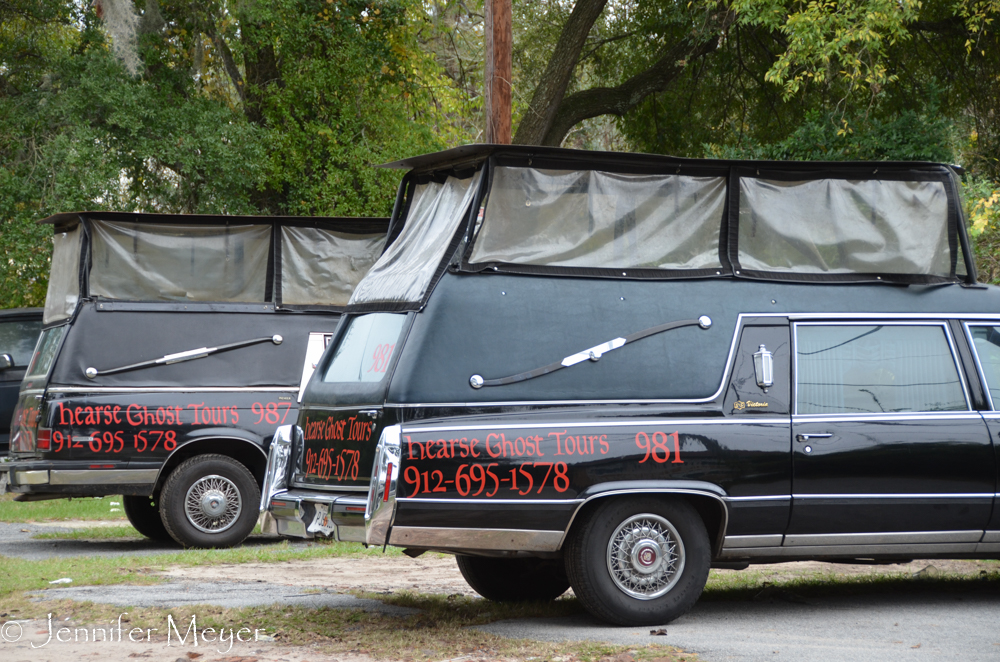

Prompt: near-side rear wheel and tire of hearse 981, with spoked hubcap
[566,497,711,626]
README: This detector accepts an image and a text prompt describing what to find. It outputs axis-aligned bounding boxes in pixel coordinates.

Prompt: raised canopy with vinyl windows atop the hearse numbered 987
[40,212,388,324]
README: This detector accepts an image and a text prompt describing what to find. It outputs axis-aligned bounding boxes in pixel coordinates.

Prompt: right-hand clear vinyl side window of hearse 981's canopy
[737,177,954,278]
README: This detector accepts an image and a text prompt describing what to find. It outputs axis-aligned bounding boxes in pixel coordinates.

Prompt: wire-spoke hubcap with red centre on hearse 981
[608,513,684,600]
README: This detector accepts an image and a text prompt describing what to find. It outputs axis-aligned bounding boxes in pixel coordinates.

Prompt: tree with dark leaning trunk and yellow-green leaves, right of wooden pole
[515,0,1000,174]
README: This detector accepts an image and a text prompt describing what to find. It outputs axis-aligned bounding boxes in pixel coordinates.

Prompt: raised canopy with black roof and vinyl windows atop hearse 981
[349,145,975,311]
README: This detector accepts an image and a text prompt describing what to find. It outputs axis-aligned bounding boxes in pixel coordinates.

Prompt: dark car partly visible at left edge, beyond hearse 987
[0,308,42,457]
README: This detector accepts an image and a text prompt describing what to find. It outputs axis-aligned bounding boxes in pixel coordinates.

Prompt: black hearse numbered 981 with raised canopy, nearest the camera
[262,146,1000,624]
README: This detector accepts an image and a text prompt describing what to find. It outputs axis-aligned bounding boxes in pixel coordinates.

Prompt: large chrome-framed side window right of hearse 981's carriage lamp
[795,323,969,414]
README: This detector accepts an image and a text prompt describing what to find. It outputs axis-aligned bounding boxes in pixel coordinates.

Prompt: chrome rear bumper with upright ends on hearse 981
[260,425,400,545]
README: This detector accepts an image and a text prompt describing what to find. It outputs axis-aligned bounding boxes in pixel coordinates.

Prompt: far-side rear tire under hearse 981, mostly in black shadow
[455,556,569,602]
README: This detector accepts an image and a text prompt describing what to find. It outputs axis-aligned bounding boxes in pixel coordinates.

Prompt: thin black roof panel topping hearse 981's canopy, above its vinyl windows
[379,144,961,173]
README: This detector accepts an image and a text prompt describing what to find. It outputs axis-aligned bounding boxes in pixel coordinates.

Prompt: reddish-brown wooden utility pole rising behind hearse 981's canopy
[484,0,513,145]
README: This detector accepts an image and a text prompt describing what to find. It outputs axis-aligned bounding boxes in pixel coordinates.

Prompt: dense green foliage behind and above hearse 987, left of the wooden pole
[0,0,458,307]
